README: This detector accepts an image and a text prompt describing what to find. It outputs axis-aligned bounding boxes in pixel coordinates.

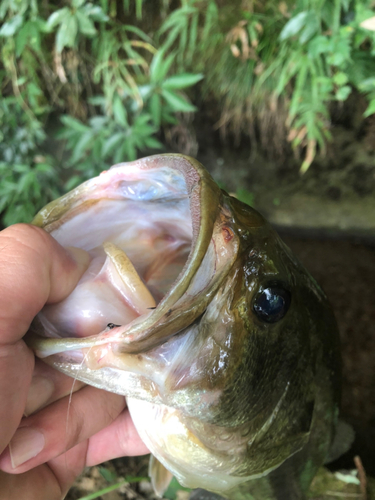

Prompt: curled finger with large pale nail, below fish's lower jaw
[0,387,125,474]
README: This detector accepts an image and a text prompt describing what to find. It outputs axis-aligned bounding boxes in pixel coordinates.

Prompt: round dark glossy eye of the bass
[253,283,291,323]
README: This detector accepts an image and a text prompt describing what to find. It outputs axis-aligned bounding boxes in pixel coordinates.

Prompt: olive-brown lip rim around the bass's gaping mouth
[27,154,238,357]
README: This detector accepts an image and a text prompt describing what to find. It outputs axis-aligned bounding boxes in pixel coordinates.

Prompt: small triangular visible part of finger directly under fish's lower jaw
[24,359,86,417]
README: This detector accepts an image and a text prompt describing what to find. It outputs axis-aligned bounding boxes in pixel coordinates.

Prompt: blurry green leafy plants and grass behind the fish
[0,0,375,225]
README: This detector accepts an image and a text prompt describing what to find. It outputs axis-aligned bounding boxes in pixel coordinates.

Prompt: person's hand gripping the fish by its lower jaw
[0,224,148,500]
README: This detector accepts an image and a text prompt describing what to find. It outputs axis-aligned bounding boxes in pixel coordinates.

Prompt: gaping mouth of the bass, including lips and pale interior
[28,155,238,395]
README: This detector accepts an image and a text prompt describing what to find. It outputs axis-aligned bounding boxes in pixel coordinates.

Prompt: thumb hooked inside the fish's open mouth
[0,224,90,344]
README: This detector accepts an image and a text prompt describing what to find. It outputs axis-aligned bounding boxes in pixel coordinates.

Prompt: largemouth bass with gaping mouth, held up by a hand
[29,155,340,500]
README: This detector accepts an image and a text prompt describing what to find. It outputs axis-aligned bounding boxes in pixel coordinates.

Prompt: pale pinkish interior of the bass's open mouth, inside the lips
[39,165,192,337]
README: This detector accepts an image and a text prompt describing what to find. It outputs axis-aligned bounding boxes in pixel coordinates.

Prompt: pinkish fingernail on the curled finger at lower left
[9,427,45,469]
